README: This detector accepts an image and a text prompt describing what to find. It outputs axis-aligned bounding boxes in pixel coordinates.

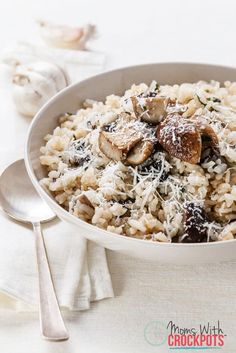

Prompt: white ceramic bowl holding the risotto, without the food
[25,63,236,264]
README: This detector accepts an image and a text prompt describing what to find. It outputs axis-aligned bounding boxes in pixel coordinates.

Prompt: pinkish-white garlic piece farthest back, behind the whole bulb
[39,21,95,50]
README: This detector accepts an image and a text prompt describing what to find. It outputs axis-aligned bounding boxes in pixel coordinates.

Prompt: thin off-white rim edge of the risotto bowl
[24,61,236,248]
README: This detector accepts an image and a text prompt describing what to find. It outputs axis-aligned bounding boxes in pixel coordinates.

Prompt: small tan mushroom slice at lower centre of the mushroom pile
[125,140,154,165]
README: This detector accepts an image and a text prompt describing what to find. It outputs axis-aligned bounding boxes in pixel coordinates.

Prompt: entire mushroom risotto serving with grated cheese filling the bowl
[40,81,236,243]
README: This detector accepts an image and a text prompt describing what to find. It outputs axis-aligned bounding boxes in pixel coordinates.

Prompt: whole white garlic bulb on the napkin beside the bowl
[13,61,67,116]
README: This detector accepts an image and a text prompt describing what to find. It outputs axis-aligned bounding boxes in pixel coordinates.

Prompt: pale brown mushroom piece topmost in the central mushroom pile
[131,96,169,124]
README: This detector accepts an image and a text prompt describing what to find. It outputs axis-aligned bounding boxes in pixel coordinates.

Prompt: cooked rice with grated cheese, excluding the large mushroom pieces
[40,81,236,242]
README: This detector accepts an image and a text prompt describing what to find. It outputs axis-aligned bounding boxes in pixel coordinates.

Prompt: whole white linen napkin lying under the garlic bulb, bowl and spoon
[0,44,113,310]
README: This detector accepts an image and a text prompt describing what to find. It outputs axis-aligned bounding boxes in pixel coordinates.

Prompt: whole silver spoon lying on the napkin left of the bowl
[0,159,69,341]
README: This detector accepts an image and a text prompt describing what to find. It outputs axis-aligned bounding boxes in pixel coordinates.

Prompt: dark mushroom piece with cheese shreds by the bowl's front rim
[182,202,208,243]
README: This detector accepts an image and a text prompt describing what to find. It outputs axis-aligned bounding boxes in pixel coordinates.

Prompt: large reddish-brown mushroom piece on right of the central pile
[157,113,202,164]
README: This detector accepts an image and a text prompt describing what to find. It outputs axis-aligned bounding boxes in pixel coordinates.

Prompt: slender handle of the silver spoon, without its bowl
[33,222,69,341]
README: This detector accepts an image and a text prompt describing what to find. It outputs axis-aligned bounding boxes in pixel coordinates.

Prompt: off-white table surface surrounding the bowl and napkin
[0,0,236,353]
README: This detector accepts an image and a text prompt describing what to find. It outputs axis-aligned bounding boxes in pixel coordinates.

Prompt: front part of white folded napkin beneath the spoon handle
[0,214,113,310]
